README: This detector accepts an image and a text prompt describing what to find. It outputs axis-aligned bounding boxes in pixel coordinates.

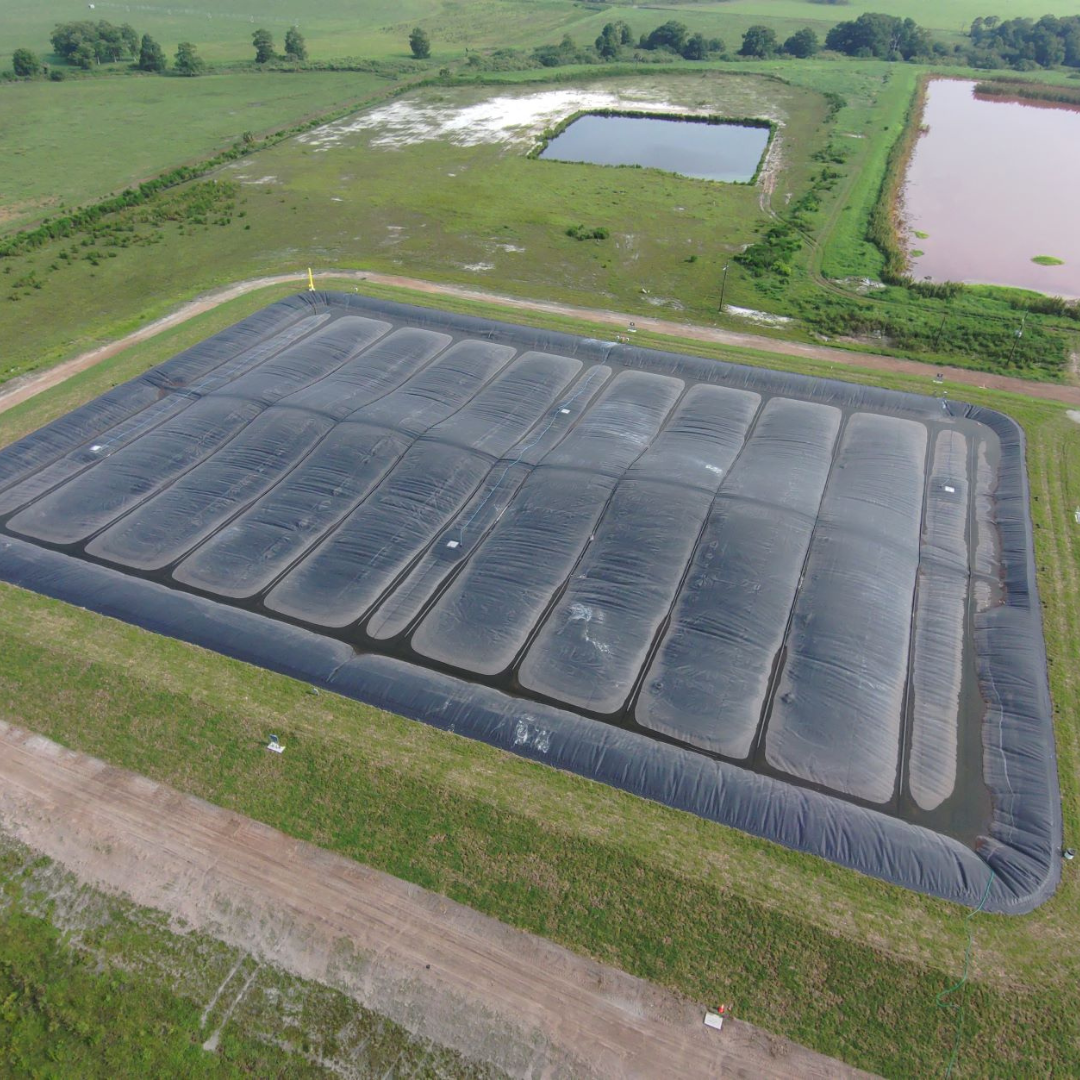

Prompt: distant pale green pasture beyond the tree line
[8,0,1076,67]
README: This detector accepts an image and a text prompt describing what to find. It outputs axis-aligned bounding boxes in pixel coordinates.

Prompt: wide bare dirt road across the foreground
[0,723,866,1080]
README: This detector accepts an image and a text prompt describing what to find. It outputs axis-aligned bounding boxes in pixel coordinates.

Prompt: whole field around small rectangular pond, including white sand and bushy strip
[0,60,1080,388]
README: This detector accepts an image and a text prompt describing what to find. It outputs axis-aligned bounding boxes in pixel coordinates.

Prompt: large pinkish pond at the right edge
[904,79,1080,297]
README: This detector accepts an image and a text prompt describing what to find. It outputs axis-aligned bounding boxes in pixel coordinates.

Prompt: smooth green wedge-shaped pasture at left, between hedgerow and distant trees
[0,71,393,230]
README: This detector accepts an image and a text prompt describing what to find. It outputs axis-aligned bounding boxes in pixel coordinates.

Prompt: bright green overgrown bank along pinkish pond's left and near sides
[730,63,1080,379]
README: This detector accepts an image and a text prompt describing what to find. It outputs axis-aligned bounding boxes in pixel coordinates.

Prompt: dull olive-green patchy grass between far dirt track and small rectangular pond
[0,73,825,378]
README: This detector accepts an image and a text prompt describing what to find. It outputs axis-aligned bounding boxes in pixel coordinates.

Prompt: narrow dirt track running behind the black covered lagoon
[0,270,1080,413]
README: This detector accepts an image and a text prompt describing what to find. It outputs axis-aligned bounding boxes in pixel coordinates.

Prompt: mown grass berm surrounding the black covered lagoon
[0,286,1080,1077]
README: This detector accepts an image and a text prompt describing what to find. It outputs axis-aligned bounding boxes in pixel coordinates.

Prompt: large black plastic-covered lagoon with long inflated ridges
[0,293,1062,913]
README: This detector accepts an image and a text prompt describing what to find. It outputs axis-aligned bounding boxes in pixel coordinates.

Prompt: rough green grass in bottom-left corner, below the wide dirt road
[0,835,494,1080]
